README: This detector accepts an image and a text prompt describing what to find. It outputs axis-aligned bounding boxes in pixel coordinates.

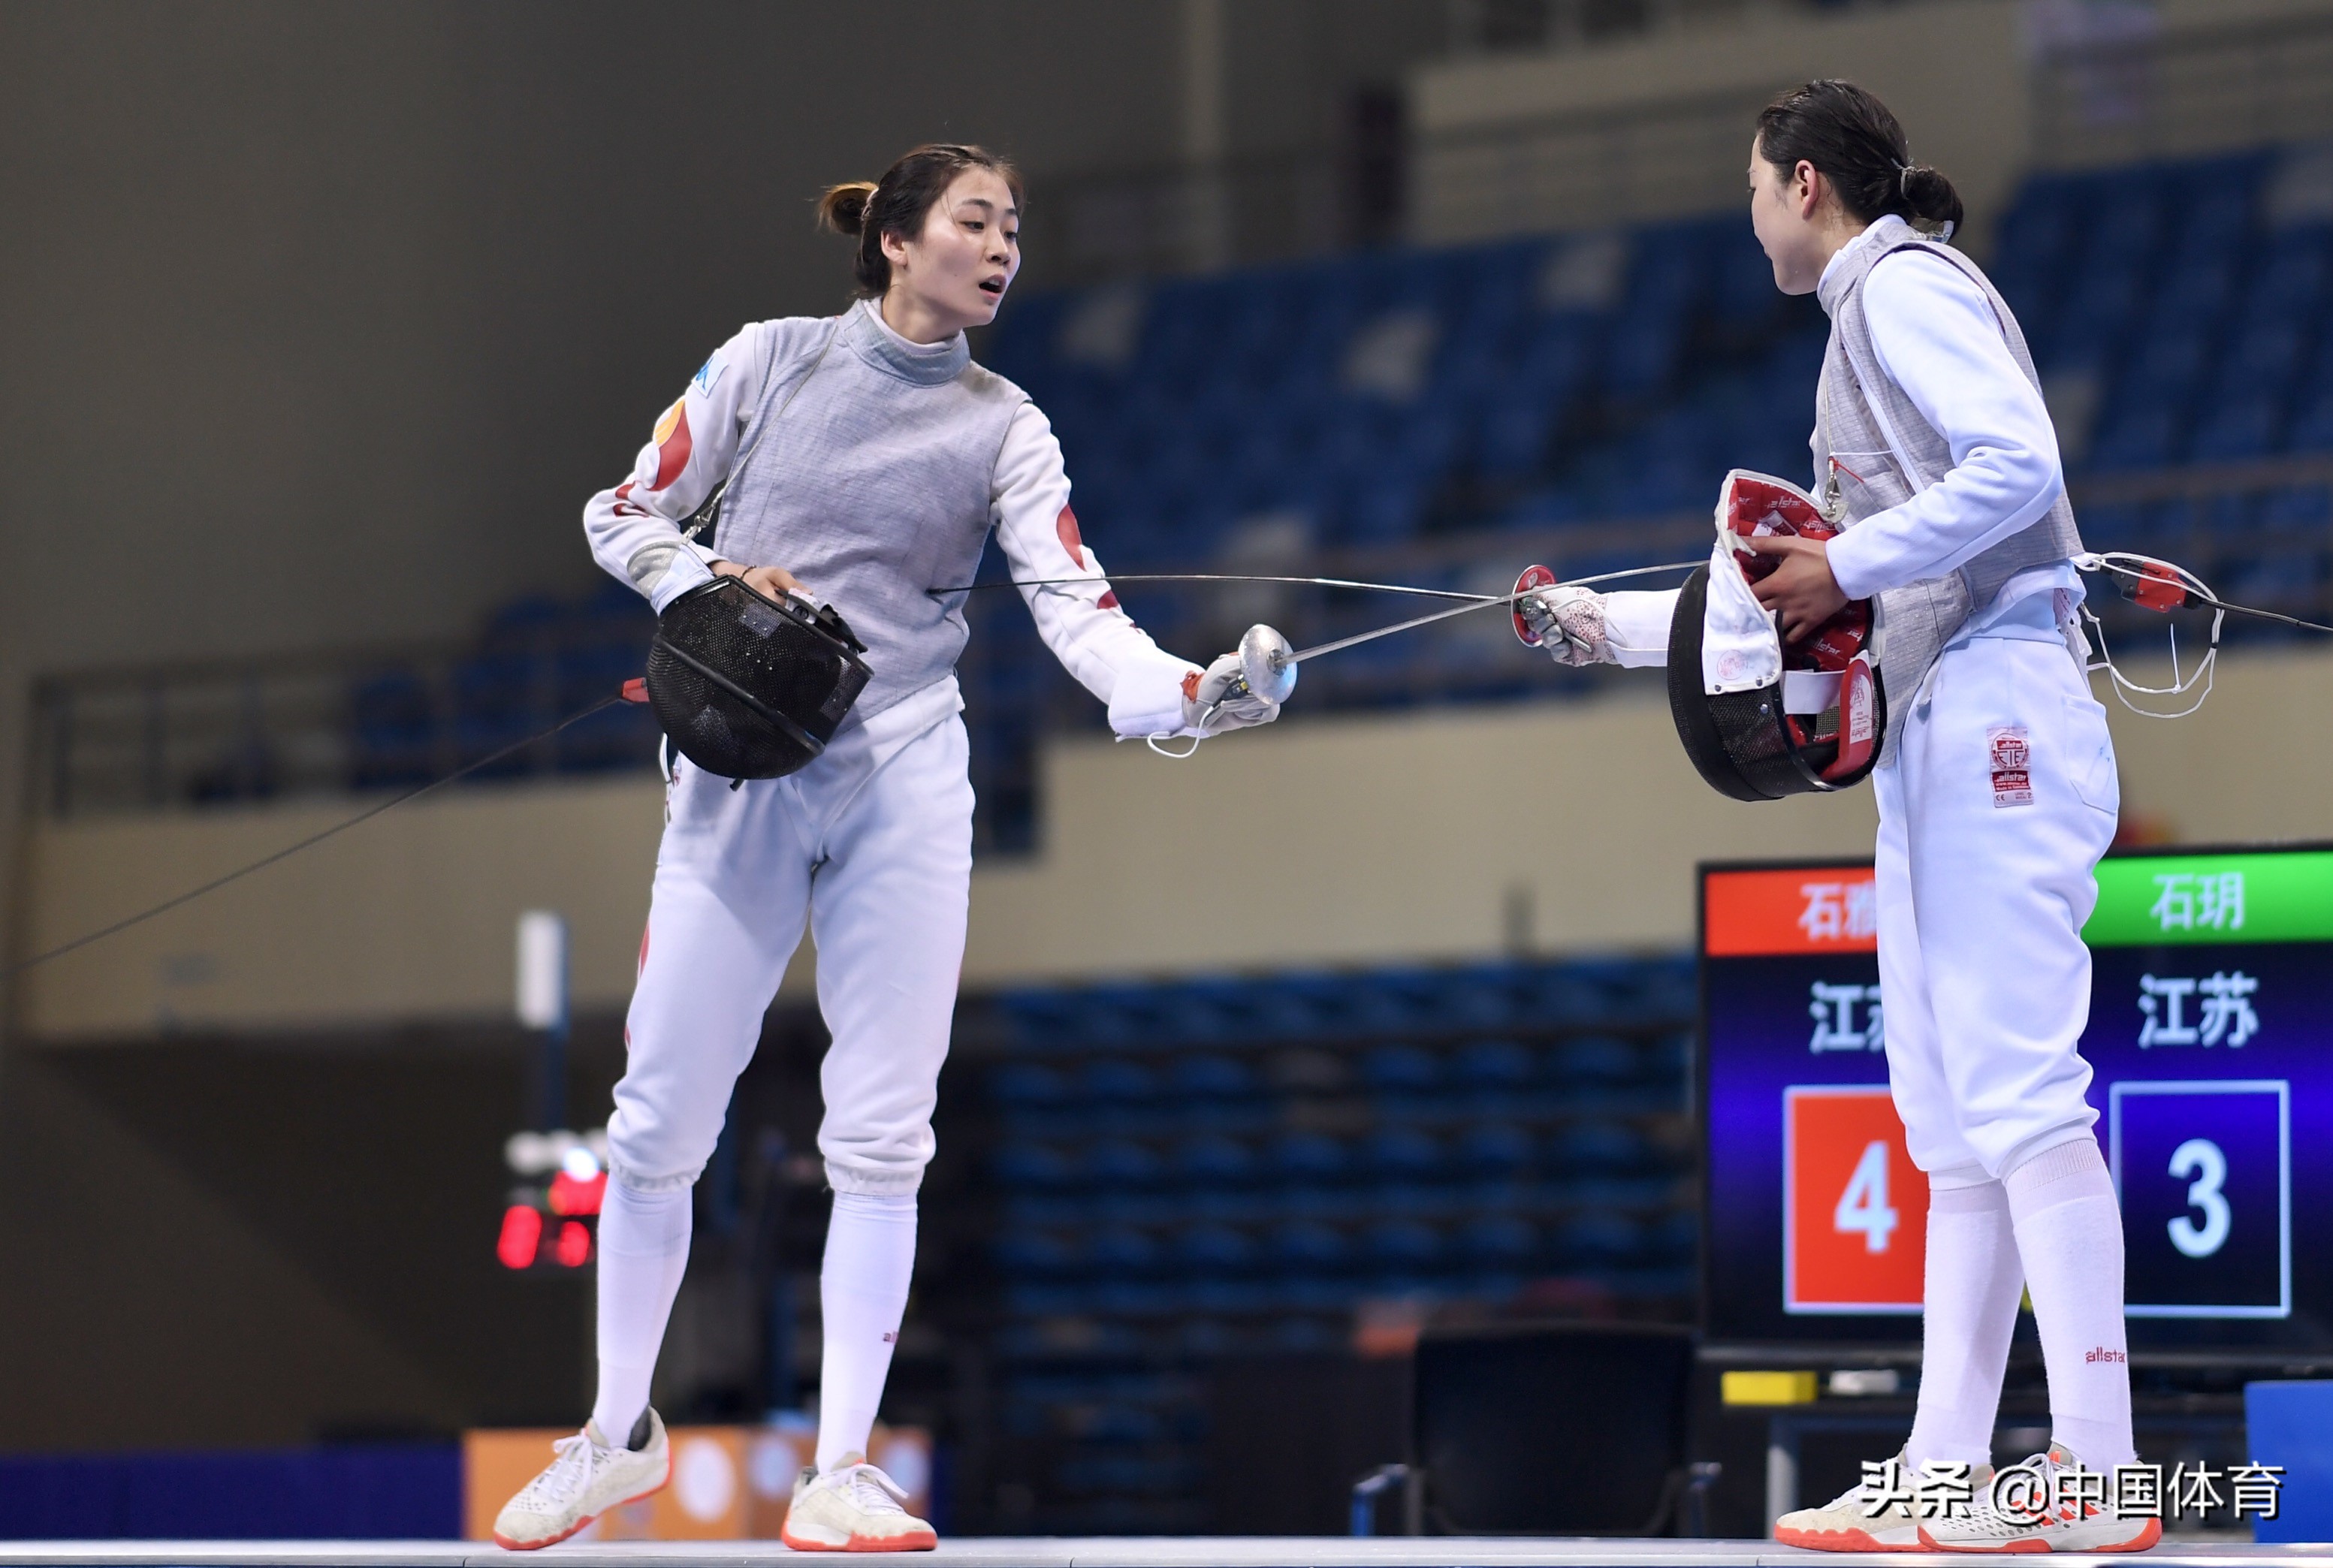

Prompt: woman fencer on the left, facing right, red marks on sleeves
[494,145,1278,1551]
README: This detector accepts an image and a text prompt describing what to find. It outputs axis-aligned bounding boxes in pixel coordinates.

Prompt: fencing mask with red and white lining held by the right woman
[1668,469,1888,801]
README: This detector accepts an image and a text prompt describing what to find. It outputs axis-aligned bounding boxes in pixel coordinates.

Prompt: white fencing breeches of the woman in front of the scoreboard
[1871,620,2120,1178]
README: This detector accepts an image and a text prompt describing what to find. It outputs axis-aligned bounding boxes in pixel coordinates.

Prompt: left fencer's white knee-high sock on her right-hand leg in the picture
[819,1193,915,1470]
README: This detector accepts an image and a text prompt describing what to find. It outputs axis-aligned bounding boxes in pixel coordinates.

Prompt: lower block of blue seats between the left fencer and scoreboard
[952,959,1696,1533]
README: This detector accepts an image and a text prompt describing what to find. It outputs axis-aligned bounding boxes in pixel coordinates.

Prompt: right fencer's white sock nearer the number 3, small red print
[2002,1136,2137,1470]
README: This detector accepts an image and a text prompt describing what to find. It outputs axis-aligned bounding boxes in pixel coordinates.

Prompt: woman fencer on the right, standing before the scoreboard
[1528,82,2162,1551]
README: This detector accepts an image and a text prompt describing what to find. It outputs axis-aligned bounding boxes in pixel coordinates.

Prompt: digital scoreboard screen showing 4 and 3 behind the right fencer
[1701,849,2333,1351]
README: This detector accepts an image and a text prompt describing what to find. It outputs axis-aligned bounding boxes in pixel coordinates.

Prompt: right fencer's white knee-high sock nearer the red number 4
[1906,1167,2025,1473]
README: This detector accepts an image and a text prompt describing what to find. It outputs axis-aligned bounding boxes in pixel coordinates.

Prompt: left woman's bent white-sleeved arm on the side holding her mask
[584,318,831,614]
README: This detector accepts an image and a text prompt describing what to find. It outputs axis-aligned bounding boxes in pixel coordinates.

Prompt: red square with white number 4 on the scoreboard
[1782,1083,1927,1313]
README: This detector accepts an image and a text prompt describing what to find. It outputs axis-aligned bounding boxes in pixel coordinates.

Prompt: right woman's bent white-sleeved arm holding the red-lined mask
[1827,249,2065,600]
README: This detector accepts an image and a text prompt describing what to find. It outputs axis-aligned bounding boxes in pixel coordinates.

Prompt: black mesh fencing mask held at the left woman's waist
[648,576,871,779]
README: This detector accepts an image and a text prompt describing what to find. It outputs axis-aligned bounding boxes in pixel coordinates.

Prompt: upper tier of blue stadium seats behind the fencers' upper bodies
[348,149,2333,852]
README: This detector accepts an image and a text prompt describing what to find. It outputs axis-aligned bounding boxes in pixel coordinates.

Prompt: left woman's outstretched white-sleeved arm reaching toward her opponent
[989,404,1199,737]
